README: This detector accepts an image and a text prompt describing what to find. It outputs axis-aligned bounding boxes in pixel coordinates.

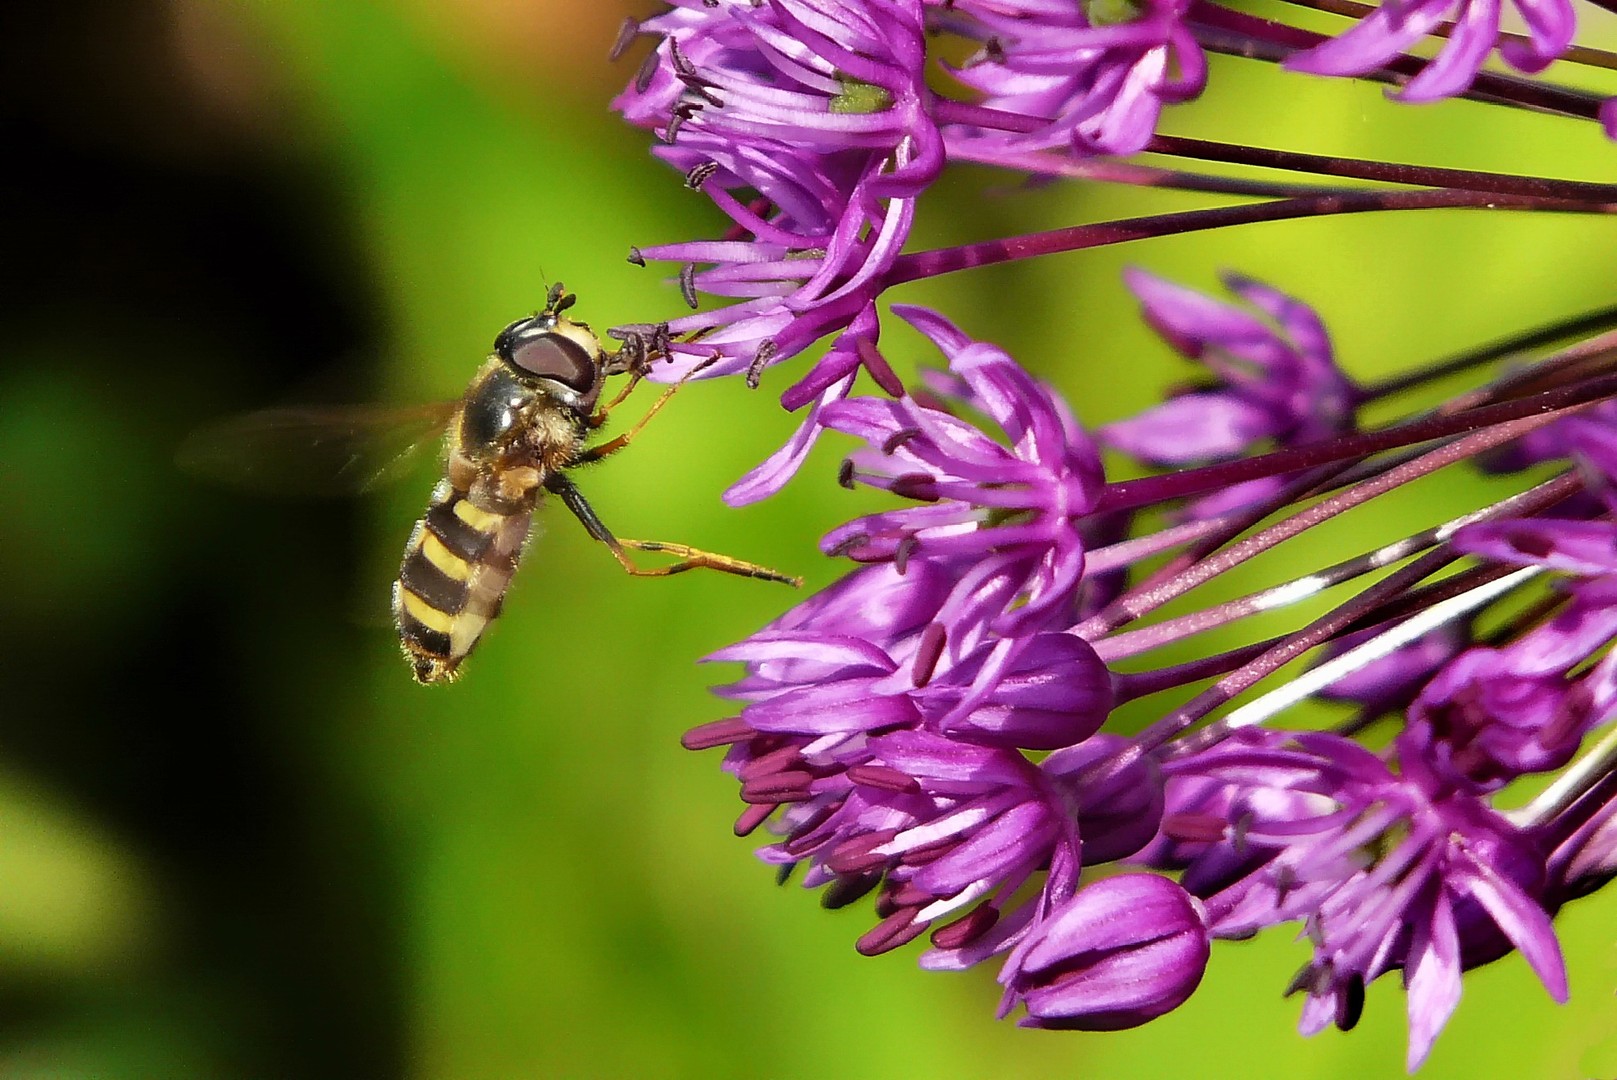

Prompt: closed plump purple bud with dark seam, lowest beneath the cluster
[999,873,1210,1031]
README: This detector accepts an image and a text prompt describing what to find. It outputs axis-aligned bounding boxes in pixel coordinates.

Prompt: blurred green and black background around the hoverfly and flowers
[9,0,1617,1080]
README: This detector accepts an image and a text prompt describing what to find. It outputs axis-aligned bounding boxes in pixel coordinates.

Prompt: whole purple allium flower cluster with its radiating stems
[616,0,1617,1069]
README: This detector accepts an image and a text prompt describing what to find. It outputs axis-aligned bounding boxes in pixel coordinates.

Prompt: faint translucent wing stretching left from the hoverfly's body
[176,401,459,496]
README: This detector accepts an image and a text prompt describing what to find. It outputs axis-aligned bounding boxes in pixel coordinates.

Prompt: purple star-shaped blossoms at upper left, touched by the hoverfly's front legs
[616,0,943,396]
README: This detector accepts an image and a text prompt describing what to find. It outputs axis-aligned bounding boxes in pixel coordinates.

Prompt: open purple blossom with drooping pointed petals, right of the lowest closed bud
[1164,731,1567,1069]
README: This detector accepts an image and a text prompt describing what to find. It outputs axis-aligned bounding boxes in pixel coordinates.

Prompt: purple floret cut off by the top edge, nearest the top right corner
[1286,0,1577,102]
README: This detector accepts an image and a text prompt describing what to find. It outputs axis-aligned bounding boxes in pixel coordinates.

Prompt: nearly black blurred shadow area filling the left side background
[0,0,403,1077]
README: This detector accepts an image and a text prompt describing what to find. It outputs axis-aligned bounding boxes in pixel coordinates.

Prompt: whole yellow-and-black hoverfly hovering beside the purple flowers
[179,283,802,684]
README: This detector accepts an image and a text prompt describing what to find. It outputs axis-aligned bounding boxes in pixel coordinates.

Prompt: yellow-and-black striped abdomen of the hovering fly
[393,480,534,682]
